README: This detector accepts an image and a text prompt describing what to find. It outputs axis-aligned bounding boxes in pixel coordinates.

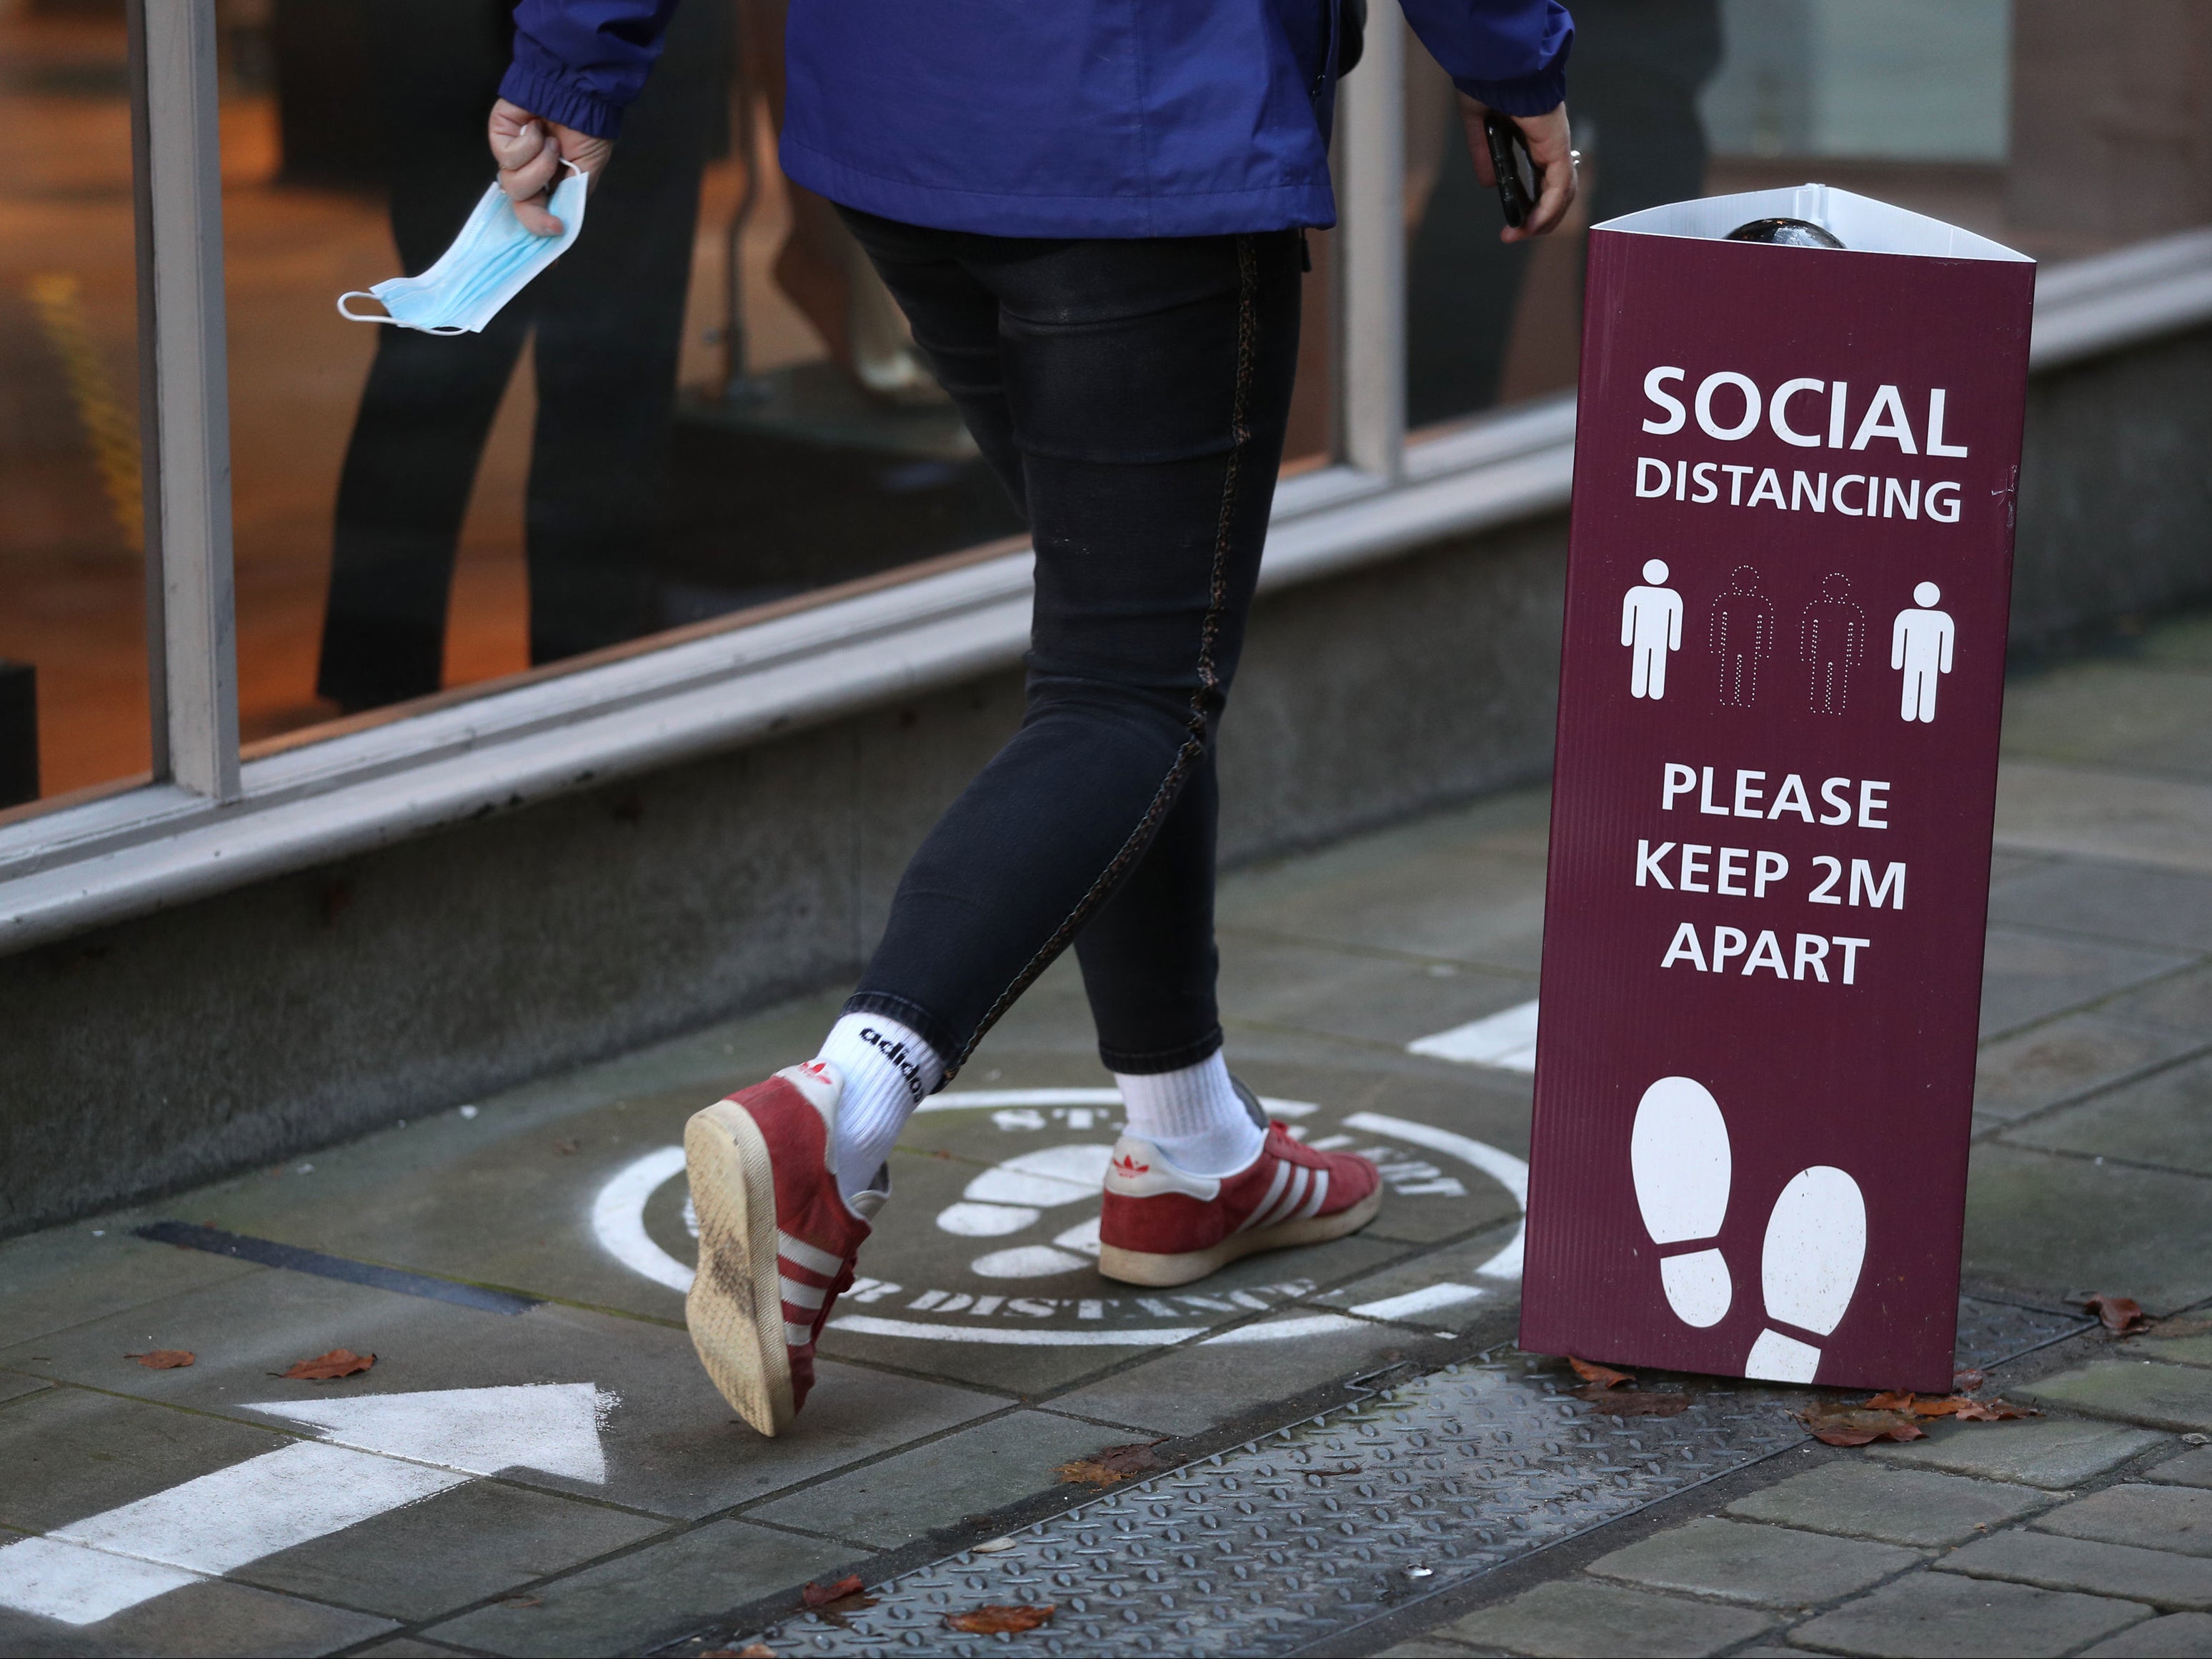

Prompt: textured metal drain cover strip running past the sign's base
[729,1298,2083,1655]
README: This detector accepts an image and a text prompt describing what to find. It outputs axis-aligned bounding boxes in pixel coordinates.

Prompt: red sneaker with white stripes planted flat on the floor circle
[1100,1124,1382,1285]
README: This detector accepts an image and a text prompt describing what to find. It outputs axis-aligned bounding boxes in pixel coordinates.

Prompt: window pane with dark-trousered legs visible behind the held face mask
[224,0,1035,741]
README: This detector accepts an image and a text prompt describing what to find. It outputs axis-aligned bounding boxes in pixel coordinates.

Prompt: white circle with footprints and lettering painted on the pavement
[591,1088,1528,1347]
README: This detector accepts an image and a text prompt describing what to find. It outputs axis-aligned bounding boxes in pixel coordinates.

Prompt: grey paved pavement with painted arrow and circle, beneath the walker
[0,619,2212,1655]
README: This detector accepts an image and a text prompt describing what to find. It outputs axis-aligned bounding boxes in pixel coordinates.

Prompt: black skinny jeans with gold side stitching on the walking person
[845,210,1300,1073]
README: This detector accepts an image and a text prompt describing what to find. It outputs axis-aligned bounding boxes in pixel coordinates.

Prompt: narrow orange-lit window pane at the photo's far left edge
[0,0,151,807]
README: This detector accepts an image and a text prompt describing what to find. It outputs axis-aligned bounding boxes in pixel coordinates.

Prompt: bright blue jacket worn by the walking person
[500,0,1575,236]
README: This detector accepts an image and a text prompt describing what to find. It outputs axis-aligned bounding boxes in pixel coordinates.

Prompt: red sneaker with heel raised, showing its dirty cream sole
[684,1060,890,1435]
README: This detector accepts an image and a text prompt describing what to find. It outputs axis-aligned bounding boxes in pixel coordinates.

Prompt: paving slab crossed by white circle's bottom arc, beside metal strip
[1053,1314,1438,1433]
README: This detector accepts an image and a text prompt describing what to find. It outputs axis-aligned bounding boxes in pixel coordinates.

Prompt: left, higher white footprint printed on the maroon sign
[1628,1077,1734,1330]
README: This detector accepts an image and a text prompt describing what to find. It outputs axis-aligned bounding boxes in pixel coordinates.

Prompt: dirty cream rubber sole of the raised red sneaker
[684,1100,799,1435]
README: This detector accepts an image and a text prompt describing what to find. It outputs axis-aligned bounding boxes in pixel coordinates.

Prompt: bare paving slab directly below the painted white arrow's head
[230,1480,666,1623]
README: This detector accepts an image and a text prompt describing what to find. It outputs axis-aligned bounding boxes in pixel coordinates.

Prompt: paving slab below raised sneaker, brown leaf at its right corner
[747,1411,1126,1548]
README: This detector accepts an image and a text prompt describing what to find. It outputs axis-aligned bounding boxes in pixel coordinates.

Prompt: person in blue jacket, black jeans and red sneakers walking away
[489,0,1575,1433]
